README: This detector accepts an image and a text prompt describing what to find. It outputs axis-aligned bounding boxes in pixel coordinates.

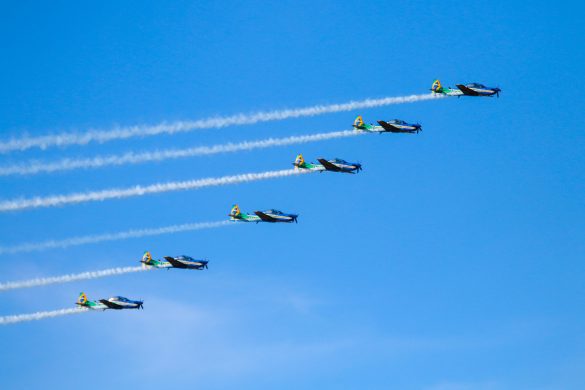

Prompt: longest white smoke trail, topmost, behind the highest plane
[0,94,443,153]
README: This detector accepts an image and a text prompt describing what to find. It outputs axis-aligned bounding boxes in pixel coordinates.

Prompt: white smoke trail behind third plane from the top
[0,169,311,212]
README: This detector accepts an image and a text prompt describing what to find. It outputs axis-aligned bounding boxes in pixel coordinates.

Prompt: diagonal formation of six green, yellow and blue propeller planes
[76,80,501,311]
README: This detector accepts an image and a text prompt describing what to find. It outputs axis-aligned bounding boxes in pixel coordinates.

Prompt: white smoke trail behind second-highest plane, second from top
[0,130,364,176]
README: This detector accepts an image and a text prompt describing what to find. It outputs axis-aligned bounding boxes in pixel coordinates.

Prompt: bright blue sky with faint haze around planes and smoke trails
[0,0,585,390]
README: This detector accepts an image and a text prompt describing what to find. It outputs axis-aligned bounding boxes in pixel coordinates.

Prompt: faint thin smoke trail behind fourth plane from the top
[0,220,230,254]
